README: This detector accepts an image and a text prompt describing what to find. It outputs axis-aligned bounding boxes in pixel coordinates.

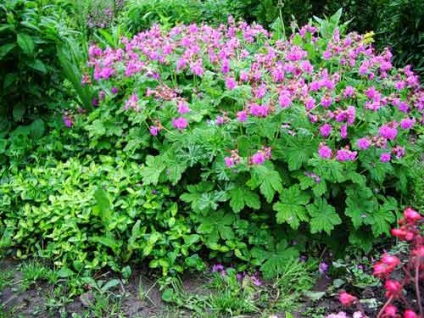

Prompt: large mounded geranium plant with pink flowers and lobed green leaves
[77,12,424,273]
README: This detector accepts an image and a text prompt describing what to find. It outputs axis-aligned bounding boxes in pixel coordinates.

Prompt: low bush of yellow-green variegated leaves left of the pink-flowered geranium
[0,156,204,275]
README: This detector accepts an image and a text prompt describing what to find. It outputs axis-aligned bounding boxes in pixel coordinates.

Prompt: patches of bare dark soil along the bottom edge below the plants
[0,260,400,318]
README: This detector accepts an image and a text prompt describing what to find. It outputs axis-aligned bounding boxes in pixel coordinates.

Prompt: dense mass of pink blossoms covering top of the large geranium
[83,17,424,166]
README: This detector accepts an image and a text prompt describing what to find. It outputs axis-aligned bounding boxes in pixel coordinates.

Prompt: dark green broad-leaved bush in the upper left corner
[0,0,68,136]
